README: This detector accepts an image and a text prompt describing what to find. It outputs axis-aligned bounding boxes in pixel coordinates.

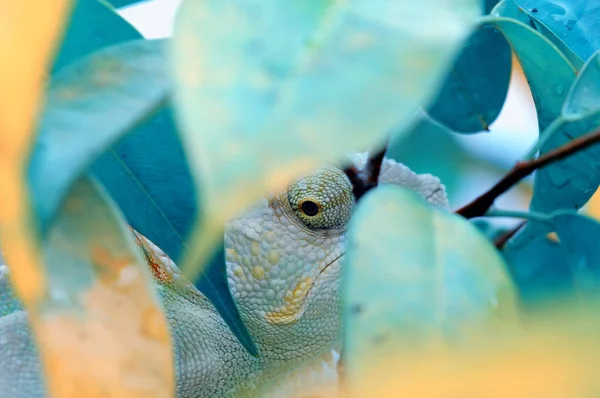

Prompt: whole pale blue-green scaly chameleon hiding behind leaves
[0,153,449,398]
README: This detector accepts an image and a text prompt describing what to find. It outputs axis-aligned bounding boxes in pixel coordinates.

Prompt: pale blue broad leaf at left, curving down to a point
[28,40,168,231]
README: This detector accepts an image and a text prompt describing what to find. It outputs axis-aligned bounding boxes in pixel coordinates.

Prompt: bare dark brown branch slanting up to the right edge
[456,131,600,218]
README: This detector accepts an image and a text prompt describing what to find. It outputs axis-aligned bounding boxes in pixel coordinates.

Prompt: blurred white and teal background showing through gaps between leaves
[119,0,538,225]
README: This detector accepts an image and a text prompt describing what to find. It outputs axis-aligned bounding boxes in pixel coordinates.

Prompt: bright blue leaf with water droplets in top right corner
[513,0,600,63]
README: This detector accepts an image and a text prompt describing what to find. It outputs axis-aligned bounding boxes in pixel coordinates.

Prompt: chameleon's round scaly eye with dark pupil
[287,167,354,230]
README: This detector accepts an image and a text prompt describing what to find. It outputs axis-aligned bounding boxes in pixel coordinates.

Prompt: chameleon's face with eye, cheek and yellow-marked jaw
[225,167,355,352]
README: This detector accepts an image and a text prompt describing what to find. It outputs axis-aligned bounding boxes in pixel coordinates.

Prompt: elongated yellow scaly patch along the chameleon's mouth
[265,252,346,325]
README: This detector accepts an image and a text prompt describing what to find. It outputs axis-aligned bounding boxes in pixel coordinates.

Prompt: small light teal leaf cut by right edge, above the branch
[562,51,600,121]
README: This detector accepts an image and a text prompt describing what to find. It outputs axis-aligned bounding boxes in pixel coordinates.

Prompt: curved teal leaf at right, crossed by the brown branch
[485,17,595,246]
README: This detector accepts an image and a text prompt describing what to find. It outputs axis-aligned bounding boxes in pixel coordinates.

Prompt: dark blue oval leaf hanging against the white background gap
[428,24,512,133]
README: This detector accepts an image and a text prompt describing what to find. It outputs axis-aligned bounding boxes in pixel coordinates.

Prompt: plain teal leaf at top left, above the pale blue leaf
[52,0,142,73]
